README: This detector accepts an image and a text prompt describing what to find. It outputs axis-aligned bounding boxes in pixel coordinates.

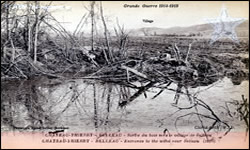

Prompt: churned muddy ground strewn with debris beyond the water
[1,36,249,84]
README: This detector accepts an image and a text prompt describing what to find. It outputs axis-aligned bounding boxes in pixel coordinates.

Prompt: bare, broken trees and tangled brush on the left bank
[1,1,248,80]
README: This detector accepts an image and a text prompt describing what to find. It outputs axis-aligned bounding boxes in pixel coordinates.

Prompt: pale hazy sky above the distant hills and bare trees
[15,1,249,31]
